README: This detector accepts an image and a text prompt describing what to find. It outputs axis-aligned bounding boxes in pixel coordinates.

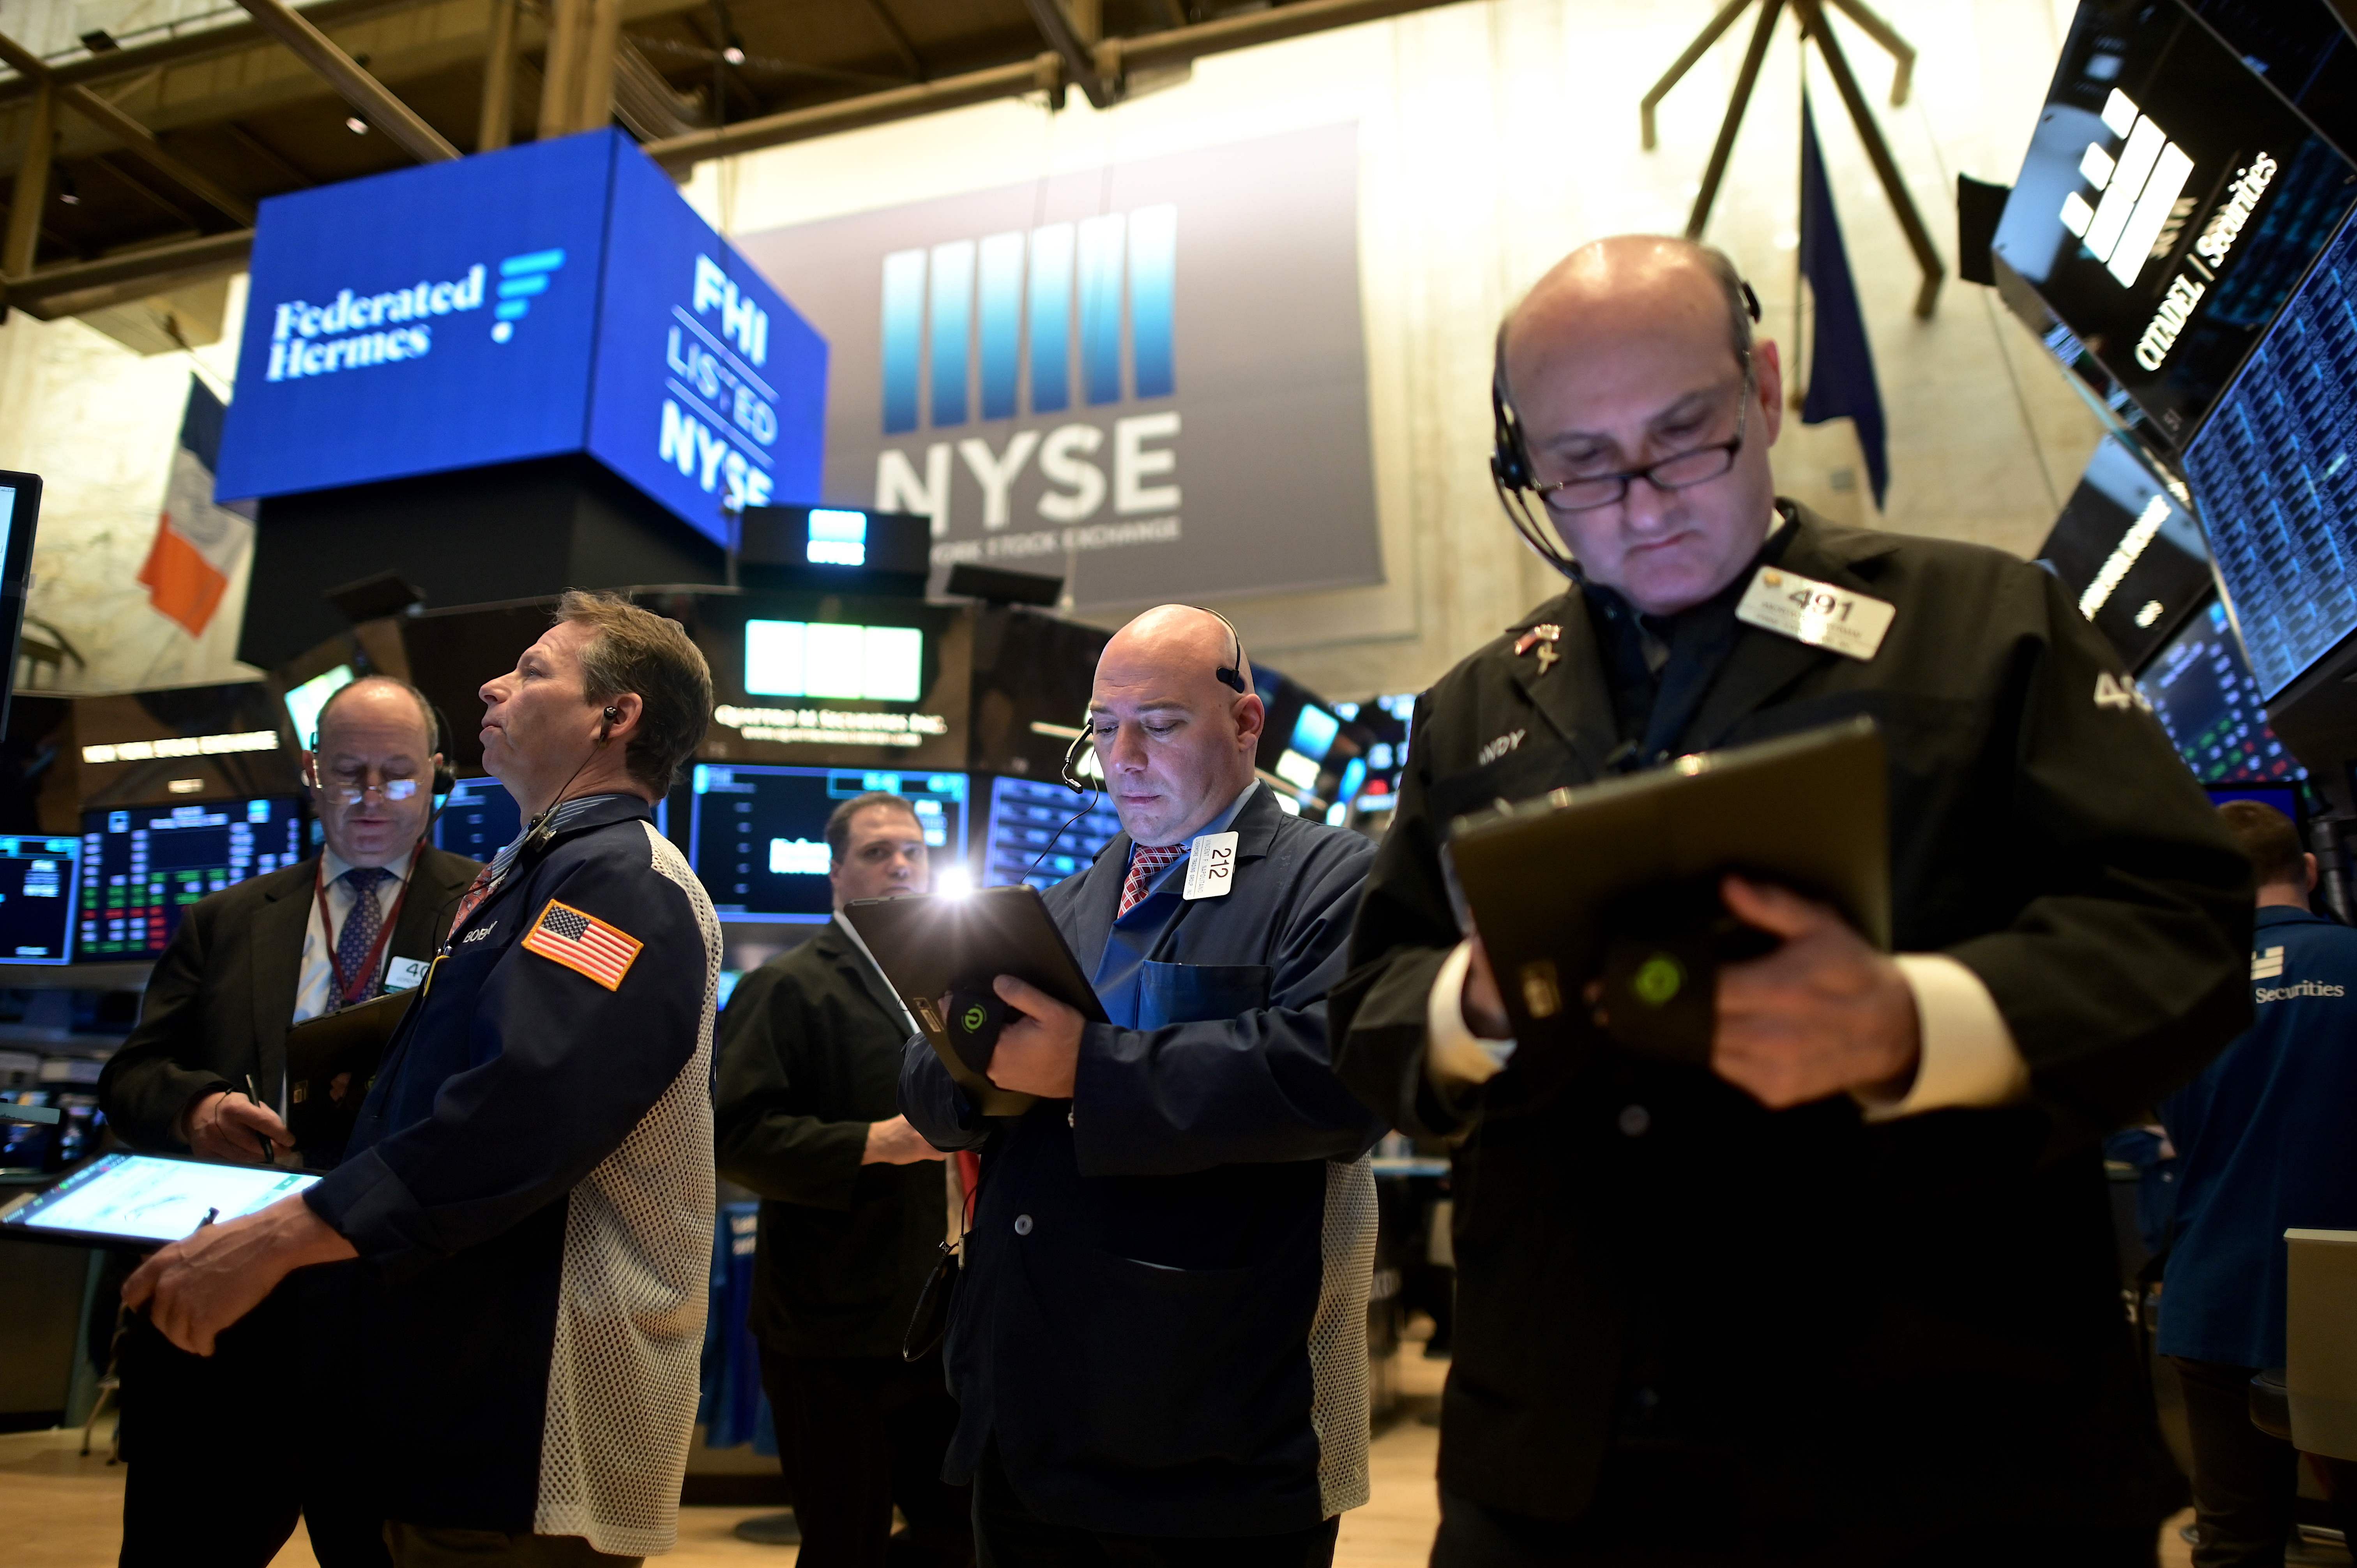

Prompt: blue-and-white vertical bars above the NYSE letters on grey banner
[879,203,1178,436]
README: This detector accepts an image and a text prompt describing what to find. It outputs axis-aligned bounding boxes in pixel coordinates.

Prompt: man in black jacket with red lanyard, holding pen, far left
[99,677,479,1568]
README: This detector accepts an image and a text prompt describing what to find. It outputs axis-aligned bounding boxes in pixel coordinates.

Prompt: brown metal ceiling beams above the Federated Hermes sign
[0,0,1454,321]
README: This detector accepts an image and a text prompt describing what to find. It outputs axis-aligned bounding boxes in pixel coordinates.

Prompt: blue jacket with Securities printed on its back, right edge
[2159,908,2357,1368]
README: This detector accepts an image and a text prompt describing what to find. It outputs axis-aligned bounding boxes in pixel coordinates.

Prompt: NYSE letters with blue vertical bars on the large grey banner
[875,203,1181,542]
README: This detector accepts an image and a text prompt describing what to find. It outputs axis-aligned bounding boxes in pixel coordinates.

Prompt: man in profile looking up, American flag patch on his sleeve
[122,592,719,1568]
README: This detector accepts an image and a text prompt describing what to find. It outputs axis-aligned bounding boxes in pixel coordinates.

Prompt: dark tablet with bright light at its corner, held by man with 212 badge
[844,886,1106,1115]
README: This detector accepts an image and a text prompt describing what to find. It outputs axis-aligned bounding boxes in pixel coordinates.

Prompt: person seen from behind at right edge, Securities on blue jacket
[2159,799,2357,1568]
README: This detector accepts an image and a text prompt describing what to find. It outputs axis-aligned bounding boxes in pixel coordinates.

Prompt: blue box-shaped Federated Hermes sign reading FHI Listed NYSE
[214,132,827,542]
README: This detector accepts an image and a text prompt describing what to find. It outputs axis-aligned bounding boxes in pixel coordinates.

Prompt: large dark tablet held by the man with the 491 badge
[1447,717,1890,1066]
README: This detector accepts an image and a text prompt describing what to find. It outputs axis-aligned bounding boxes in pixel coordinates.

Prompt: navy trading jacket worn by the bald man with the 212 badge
[900,788,1381,1535]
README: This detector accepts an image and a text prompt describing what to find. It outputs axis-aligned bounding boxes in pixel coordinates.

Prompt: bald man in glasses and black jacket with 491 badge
[1332,236,2251,1568]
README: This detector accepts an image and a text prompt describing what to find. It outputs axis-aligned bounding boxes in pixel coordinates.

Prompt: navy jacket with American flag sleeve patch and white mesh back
[306,795,719,1556]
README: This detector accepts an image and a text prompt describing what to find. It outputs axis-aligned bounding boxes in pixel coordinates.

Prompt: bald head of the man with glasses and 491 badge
[1502,233,1784,615]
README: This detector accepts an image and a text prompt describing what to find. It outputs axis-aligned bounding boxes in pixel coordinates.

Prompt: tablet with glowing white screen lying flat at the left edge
[0,1153,318,1247]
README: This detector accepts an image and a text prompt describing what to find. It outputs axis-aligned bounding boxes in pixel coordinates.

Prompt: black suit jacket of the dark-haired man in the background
[714,922,950,1358]
